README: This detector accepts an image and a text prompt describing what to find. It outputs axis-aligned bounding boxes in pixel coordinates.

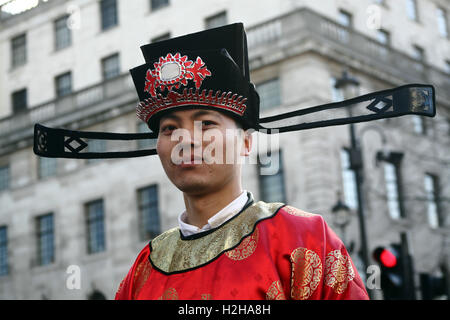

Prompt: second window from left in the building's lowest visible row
[36,213,55,266]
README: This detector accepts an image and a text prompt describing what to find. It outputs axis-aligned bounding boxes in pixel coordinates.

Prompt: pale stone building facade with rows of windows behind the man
[0,0,450,299]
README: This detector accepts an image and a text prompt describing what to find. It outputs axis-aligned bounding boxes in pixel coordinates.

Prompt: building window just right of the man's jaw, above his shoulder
[258,151,286,203]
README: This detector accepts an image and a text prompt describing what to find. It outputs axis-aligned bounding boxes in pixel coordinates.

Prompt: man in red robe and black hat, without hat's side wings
[116,24,368,300]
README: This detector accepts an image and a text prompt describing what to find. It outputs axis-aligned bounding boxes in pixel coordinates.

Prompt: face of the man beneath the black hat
[157,109,251,195]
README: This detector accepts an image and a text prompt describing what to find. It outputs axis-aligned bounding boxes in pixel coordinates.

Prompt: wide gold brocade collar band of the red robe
[150,201,283,273]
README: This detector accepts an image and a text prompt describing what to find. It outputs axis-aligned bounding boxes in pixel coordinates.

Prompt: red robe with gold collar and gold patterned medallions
[116,201,368,300]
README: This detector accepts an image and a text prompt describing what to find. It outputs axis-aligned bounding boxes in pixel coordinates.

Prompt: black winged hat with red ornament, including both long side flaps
[33,23,436,159]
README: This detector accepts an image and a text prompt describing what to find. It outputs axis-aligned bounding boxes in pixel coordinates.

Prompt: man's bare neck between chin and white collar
[183,184,242,228]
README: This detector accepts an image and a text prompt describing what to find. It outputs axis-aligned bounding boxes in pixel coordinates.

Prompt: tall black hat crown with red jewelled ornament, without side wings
[130,23,259,132]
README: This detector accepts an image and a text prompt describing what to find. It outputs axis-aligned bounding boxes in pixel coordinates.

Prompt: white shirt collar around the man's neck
[178,190,248,237]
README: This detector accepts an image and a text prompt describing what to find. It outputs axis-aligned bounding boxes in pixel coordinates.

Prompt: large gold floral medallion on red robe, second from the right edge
[291,248,322,300]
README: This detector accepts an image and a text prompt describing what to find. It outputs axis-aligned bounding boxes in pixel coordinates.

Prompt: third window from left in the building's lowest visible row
[86,200,106,254]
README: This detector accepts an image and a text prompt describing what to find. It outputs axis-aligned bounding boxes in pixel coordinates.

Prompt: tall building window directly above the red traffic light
[384,161,403,219]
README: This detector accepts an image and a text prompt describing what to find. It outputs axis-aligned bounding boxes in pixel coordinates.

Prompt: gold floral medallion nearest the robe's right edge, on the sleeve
[325,250,355,294]
